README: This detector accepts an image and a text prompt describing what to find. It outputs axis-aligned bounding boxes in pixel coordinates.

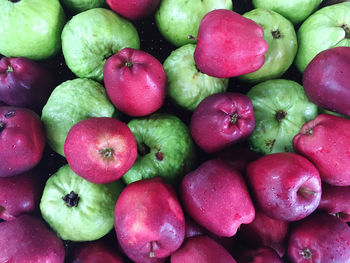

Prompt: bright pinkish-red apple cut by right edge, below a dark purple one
[293,114,350,186]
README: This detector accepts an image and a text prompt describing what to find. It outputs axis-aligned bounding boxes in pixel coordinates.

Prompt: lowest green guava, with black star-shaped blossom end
[40,164,124,241]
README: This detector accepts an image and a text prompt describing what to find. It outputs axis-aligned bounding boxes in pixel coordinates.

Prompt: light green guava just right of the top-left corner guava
[62,8,140,82]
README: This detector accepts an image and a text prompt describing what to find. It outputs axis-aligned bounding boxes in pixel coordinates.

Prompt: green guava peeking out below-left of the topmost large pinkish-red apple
[163,44,228,111]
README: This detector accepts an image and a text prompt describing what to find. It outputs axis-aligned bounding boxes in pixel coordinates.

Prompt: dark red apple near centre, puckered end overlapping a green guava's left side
[190,92,255,153]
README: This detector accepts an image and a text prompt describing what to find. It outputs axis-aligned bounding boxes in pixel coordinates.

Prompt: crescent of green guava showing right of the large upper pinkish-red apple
[239,8,298,83]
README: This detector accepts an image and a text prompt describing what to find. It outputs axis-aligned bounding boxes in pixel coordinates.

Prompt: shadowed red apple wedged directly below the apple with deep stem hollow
[239,210,289,257]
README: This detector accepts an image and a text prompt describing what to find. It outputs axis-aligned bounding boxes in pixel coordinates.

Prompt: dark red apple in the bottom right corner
[288,213,350,263]
